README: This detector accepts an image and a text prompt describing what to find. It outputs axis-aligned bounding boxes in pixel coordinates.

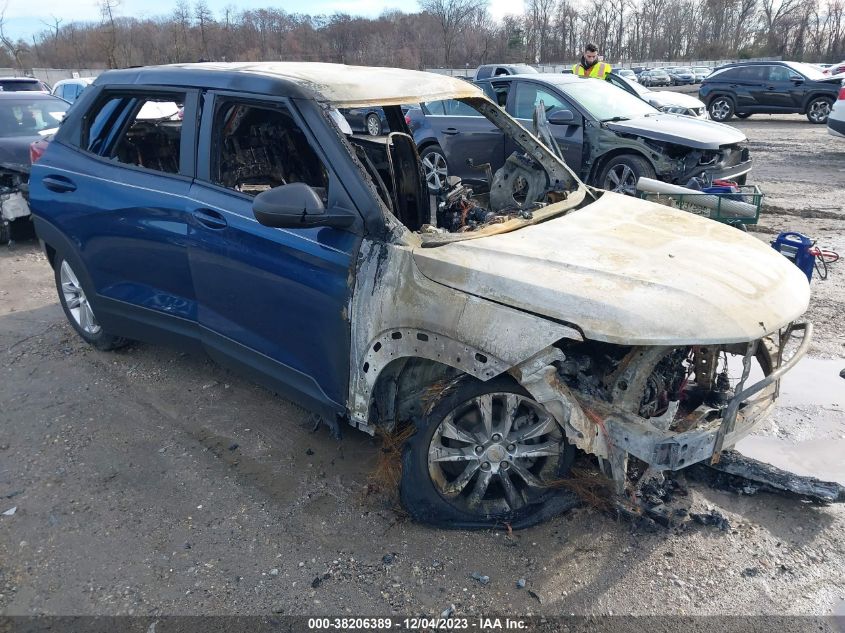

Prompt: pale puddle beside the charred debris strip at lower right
[734,435,845,486]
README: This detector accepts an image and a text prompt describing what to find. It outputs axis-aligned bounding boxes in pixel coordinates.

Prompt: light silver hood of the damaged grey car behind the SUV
[605,114,745,150]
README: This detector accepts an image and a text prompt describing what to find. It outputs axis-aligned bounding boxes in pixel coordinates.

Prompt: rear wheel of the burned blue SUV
[53,255,128,351]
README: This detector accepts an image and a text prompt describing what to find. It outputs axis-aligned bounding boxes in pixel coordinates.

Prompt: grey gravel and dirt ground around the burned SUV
[0,111,845,615]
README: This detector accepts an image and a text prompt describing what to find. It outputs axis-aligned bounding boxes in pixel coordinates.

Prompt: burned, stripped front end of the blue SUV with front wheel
[324,78,812,527]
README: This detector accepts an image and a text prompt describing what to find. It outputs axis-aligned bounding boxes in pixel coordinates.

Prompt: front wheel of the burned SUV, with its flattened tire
[399,376,578,529]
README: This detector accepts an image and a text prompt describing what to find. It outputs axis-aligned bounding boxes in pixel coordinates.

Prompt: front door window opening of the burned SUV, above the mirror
[211,101,329,204]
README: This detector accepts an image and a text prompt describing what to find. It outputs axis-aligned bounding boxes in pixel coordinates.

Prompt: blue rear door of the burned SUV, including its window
[33,88,202,340]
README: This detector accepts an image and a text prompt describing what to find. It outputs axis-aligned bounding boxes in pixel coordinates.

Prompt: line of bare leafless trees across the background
[0,0,845,71]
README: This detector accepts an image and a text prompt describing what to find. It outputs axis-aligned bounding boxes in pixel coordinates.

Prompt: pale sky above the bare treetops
[0,0,522,41]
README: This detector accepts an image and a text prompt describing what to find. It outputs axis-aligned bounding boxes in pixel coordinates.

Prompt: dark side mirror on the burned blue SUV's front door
[252,182,355,229]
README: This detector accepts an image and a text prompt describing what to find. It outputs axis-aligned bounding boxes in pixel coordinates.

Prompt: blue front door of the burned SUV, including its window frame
[189,92,360,412]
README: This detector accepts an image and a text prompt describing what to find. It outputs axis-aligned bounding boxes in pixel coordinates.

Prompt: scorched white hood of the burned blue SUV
[414,193,810,345]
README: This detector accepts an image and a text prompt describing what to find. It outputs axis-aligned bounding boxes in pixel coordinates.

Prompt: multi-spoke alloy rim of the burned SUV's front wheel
[428,392,565,515]
